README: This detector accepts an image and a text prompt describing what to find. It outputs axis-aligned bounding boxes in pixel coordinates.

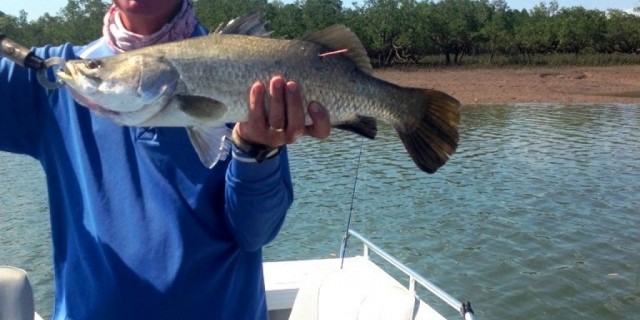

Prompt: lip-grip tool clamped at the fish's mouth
[0,32,66,90]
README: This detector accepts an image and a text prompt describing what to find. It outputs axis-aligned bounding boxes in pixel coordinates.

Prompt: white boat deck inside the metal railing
[264,256,445,320]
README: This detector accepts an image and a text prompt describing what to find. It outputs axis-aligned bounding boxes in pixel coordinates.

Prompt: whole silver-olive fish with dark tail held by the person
[56,13,460,173]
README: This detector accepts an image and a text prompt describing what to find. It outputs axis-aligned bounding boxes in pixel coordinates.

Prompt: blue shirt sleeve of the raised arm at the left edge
[0,45,73,158]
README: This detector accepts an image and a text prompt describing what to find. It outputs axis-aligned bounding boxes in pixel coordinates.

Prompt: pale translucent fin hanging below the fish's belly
[187,125,231,169]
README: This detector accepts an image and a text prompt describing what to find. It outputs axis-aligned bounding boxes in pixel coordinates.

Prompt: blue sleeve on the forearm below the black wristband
[226,148,293,251]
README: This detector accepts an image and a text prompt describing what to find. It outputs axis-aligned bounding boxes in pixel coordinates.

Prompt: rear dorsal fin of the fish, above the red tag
[300,24,373,74]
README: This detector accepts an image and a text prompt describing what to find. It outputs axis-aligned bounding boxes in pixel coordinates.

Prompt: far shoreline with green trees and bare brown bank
[0,0,640,105]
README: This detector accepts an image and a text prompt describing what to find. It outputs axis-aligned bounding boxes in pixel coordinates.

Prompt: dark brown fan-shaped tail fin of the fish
[394,89,460,173]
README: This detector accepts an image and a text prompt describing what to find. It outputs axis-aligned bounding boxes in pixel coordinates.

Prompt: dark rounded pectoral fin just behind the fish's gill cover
[169,95,227,123]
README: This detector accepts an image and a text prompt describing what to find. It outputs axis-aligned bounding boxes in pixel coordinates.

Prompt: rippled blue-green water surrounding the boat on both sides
[0,105,640,319]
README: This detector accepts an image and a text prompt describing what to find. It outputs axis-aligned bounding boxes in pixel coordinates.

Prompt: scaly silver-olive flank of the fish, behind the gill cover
[151,35,411,125]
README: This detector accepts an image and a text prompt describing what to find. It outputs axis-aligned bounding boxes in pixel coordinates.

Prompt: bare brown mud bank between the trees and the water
[375,66,640,105]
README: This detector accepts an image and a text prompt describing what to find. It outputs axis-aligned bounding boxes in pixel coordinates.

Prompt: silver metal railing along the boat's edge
[349,229,475,320]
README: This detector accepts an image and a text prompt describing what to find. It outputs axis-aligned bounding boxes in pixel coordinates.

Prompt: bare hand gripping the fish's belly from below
[233,76,331,148]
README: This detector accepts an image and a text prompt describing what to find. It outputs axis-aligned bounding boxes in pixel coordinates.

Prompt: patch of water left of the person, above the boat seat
[0,152,53,318]
